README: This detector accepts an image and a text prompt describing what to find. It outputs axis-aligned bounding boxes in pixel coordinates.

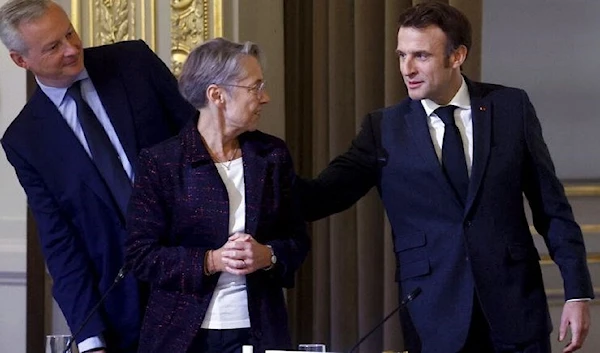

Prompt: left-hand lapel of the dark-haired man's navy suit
[404,100,463,207]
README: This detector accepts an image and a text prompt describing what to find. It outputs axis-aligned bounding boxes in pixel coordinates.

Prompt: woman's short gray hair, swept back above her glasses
[179,38,261,109]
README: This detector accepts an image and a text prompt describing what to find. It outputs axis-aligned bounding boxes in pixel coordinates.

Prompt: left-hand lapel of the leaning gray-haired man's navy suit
[30,88,120,214]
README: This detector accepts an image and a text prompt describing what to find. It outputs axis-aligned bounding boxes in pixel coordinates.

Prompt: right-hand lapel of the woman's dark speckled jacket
[240,136,268,236]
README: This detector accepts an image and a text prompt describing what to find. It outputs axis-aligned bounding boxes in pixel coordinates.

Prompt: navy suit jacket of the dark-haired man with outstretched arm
[299,80,593,352]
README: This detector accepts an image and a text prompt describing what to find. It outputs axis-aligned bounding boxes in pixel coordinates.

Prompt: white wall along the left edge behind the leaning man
[0,0,28,353]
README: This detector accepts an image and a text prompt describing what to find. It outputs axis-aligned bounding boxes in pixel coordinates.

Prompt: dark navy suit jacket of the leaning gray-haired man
[2,41,195,352]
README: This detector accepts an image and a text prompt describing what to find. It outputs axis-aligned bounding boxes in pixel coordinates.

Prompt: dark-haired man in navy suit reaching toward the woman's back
[299,2,593,353]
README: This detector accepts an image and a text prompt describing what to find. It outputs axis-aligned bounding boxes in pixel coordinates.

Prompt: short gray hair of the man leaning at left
[0,0,53,54]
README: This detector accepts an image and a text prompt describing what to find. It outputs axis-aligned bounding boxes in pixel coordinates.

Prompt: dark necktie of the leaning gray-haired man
[67,81,131,215]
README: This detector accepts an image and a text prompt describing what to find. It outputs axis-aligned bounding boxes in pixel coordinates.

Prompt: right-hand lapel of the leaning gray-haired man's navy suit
[85,51,138,174]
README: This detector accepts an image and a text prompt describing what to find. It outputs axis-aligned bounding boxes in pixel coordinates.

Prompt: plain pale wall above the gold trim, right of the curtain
[482,0,600,180]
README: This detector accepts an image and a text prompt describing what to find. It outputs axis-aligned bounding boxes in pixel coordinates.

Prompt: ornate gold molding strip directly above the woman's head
[171,0,223,76]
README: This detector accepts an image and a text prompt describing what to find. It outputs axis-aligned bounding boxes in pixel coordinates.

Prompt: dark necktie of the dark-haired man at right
[435,105,469,205]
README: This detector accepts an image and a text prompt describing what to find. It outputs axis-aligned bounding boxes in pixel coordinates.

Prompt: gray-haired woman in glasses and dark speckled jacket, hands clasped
[126,38,310,353]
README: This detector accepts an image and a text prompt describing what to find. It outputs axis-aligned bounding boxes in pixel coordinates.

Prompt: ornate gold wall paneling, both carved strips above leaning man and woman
[70,0,223,75]
